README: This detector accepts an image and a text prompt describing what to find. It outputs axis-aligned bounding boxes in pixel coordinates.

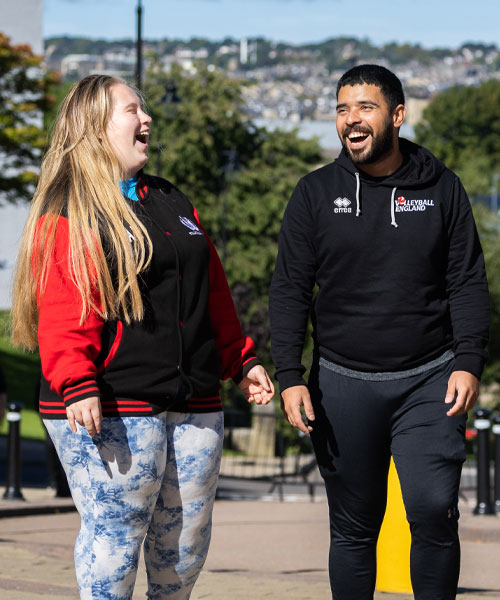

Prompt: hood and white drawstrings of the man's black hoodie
[335,138,446,228]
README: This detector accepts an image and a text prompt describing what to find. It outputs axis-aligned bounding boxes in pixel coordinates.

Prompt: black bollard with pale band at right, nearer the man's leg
[473,406,495,515]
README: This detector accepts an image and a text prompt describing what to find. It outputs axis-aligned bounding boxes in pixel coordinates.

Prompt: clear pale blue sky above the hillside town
[43,0,500,48]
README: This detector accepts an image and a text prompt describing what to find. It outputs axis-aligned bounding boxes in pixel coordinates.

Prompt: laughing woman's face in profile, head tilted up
[106,83,151,180]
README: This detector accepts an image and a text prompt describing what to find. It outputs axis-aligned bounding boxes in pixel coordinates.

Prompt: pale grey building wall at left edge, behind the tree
[0,0,43,309]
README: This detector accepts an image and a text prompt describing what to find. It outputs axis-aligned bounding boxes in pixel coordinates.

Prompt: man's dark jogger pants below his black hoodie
[309,360,466,600]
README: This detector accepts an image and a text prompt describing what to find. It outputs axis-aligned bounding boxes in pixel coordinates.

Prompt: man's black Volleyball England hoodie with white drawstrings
[270,139,489,391]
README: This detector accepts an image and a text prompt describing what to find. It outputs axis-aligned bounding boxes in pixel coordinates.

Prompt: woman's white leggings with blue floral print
[44,412,224,600]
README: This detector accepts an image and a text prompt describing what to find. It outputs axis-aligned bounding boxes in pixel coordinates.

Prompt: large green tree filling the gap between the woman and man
[145,65,322,362]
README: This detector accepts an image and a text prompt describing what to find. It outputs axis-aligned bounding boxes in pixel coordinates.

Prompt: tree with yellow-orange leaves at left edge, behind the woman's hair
[0,33,54,202]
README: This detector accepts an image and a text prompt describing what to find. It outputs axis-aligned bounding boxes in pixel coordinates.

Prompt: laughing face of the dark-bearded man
[337,84,398,165]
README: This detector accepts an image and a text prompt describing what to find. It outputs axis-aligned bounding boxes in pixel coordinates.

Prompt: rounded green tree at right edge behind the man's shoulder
[415,80,500,194]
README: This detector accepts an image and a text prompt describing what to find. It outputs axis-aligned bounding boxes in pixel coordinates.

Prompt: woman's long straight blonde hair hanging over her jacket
[12,75,152,349]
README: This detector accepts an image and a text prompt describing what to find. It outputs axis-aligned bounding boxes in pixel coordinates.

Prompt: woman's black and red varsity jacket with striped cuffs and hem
[38,175,259,419]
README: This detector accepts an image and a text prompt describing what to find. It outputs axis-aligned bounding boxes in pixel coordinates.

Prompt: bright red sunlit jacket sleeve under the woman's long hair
[38,217,103,406]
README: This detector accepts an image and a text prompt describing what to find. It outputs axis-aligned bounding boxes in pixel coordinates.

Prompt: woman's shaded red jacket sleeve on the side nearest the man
[193,208,260,383]
